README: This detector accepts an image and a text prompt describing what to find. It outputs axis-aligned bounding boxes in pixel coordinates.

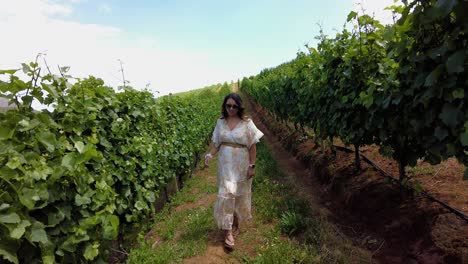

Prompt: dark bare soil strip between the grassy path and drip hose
[247,94,468,263]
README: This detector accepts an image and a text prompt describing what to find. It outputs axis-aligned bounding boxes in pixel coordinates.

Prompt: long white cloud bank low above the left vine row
[0,0,241,94]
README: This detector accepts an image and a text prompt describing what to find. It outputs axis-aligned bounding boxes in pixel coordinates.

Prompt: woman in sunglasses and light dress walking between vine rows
[205,93,263,250]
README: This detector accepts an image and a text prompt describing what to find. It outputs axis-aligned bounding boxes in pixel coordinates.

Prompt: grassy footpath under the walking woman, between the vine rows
[129,85,375,264]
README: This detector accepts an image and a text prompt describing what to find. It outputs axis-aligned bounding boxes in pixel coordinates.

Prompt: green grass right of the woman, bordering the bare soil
[249,143,369,263]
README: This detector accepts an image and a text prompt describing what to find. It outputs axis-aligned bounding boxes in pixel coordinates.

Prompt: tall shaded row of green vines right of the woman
[242,0,468,183]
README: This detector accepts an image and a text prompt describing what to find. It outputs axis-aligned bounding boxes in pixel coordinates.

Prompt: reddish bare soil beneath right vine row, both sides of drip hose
[250,95,468,263]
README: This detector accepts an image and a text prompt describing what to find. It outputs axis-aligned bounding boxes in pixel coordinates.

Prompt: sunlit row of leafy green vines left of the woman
[0,62,229,263]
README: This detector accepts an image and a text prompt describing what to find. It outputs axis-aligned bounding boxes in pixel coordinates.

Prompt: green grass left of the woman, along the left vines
[127,148,217,263]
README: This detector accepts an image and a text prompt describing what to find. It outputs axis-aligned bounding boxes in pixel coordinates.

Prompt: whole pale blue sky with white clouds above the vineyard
[0,0,393,96]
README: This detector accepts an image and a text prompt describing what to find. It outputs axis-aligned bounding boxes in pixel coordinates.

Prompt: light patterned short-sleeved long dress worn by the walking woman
[212,119,263,230]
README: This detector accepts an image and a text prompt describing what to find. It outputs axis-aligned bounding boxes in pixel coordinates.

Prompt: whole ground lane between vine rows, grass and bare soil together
[127,86,468,264]
